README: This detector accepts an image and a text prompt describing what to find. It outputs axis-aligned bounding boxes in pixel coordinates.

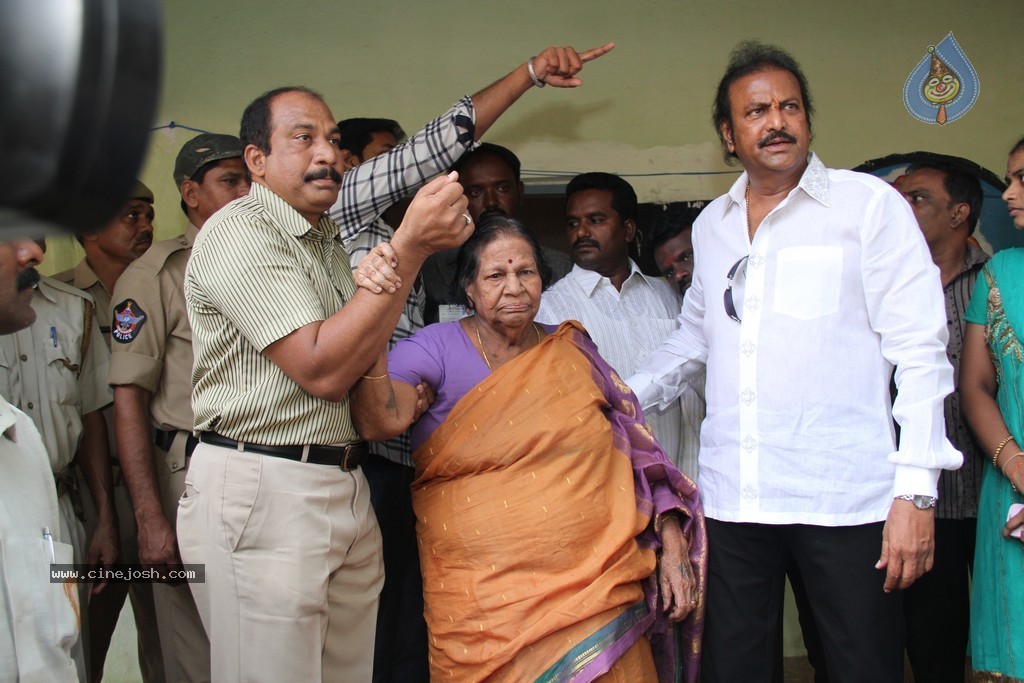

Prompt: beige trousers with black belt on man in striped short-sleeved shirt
[178,443,384,683]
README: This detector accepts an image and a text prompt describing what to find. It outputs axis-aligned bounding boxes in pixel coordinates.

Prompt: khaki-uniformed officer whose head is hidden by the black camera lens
[0,270,118,680]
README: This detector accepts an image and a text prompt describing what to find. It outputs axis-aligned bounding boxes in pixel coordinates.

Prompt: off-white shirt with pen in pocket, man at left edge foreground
[0,396,79,683]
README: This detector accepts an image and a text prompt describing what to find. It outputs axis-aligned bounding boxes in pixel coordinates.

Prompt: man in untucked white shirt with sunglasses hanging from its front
[629,43,961,682]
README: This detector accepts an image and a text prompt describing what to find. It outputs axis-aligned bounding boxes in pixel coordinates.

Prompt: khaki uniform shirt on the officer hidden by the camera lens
[0,278,114,472]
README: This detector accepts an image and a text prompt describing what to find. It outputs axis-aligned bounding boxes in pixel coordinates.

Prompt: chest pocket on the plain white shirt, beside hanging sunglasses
[773,246,843,321]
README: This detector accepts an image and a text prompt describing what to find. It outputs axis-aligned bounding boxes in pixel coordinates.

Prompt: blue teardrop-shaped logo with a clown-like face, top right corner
[903,32,981,126]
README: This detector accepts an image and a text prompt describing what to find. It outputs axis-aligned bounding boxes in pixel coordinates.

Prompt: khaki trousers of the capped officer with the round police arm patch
[153,431,210,683]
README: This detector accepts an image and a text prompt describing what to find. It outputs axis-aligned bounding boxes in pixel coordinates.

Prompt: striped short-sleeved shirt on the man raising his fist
[184,183,360,445]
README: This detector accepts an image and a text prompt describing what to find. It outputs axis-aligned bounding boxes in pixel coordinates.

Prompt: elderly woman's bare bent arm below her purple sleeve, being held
[351,353,425,441]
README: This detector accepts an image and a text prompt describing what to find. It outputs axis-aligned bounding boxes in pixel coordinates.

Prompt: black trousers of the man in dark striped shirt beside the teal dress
[903,519,978,683]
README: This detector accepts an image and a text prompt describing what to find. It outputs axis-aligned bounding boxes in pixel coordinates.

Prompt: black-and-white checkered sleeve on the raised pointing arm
[330,95,476,237]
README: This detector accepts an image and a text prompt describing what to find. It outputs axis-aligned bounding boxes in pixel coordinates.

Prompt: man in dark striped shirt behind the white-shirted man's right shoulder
[899,161,988,683]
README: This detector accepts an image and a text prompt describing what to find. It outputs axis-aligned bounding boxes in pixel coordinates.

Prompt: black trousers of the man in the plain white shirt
[700,519,903,683]
